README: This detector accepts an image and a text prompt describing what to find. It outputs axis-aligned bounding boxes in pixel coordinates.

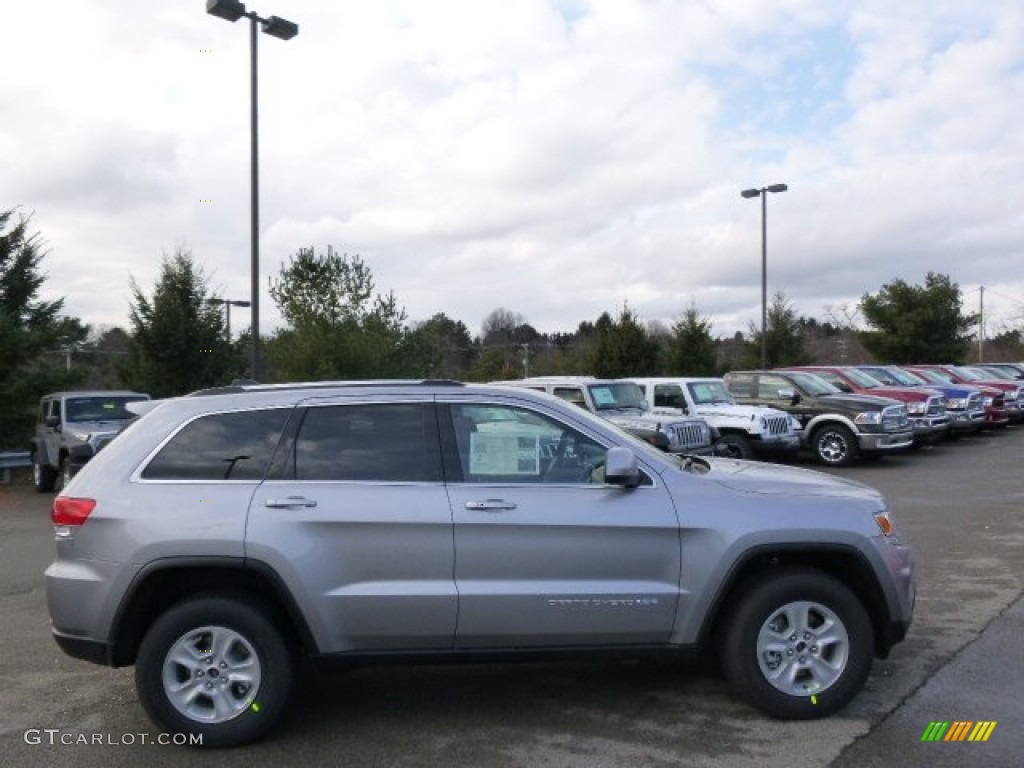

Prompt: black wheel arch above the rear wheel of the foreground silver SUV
[110,557,316,667]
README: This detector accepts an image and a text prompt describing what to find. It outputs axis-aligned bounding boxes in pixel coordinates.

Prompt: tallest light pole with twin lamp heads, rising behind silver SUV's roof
[206,0,299,381]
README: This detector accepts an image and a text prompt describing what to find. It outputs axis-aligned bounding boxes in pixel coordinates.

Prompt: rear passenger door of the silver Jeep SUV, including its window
[246,398,457,652]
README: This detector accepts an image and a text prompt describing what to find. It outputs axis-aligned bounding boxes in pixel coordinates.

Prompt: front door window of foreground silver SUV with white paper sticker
[451,403,605,483]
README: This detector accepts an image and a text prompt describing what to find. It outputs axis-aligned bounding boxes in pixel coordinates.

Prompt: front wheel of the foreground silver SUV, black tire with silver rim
[722,568,873,720]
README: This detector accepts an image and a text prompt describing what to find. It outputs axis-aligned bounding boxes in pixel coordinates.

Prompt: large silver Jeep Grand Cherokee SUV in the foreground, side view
[46,382,914,746]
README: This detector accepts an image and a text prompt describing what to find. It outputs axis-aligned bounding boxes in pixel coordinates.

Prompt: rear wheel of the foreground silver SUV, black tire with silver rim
[135,596,295,746]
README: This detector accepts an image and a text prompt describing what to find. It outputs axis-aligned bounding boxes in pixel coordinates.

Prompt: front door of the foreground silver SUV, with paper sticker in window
[439,399,680,647]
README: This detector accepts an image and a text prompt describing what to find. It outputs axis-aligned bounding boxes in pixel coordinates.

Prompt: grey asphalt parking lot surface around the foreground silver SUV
[0,428,1024,768]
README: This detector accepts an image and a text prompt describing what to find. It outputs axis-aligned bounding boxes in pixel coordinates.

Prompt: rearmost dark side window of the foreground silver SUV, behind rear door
[142,409,290,480]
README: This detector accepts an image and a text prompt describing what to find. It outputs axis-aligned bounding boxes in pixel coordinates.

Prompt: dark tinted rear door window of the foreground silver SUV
[295,402,441,482]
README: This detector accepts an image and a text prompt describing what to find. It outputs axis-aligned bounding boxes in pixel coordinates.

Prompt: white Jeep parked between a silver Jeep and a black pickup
[632,377,801,461]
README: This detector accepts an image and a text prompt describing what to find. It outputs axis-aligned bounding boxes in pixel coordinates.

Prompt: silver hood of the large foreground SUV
[706,459,884,505]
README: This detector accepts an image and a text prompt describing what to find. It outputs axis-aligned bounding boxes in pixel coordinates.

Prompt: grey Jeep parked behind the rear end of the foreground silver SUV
[30,389,150,493]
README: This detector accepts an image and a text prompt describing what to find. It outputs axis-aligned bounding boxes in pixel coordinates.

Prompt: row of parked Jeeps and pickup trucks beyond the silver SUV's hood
[495,364,1024,466]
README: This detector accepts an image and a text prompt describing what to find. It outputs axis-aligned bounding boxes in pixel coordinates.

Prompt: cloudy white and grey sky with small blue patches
[0,0,1024,342]
